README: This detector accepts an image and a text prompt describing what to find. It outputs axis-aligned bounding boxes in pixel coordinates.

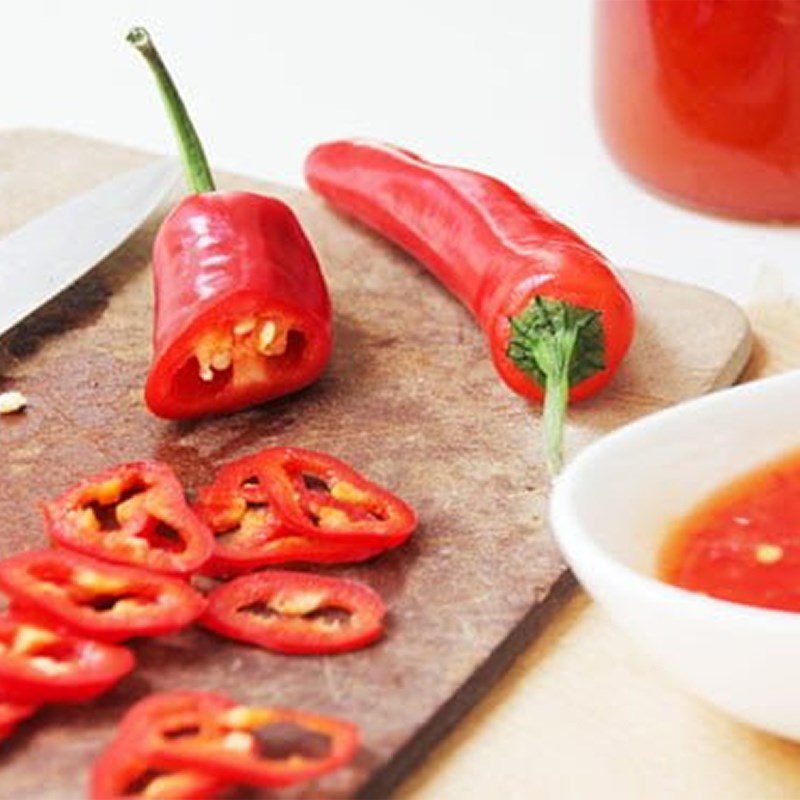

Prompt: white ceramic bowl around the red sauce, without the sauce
[550,372,800,740]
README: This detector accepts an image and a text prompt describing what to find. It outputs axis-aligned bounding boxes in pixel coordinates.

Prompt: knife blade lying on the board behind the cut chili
[0,160,179,335]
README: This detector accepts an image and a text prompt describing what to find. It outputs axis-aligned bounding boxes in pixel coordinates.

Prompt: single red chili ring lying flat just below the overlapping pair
[200,570,386,654]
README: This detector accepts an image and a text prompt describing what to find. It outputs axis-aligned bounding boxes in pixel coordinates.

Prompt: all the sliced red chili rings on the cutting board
[0,448,417,800]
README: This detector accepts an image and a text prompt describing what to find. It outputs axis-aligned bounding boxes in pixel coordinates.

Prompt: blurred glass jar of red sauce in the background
[595,0,800,220]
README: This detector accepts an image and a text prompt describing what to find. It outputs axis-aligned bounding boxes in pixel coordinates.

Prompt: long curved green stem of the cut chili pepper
[125,28,214,194]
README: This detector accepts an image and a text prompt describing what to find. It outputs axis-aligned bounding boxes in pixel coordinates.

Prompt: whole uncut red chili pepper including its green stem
[306,141,634,471]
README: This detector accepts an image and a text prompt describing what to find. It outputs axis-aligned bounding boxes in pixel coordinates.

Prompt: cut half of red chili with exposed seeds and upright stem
[128,28,331,419]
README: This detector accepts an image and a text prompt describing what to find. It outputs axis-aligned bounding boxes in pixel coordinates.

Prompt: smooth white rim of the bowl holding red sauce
[548,370,800,634]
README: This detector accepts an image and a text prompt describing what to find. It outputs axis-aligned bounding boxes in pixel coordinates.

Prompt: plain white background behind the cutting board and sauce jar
[0,0,800,299]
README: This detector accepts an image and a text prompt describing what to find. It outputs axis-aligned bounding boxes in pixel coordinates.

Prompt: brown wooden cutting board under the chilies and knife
[0,131,750,800]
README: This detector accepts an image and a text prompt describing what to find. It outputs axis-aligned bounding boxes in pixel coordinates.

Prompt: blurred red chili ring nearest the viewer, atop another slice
[110,692,359,788]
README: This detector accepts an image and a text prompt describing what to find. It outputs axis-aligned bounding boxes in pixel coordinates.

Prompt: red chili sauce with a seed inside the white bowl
[659,451,800,611]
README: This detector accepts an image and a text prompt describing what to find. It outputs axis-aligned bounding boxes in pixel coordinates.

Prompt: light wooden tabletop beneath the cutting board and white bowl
[399,290,800,800]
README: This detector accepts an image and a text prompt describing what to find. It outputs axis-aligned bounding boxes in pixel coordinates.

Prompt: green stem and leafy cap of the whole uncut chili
[507,297,605,475]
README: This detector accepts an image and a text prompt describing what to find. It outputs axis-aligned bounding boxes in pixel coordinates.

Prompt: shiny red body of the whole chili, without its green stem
[305,140,634,400]
